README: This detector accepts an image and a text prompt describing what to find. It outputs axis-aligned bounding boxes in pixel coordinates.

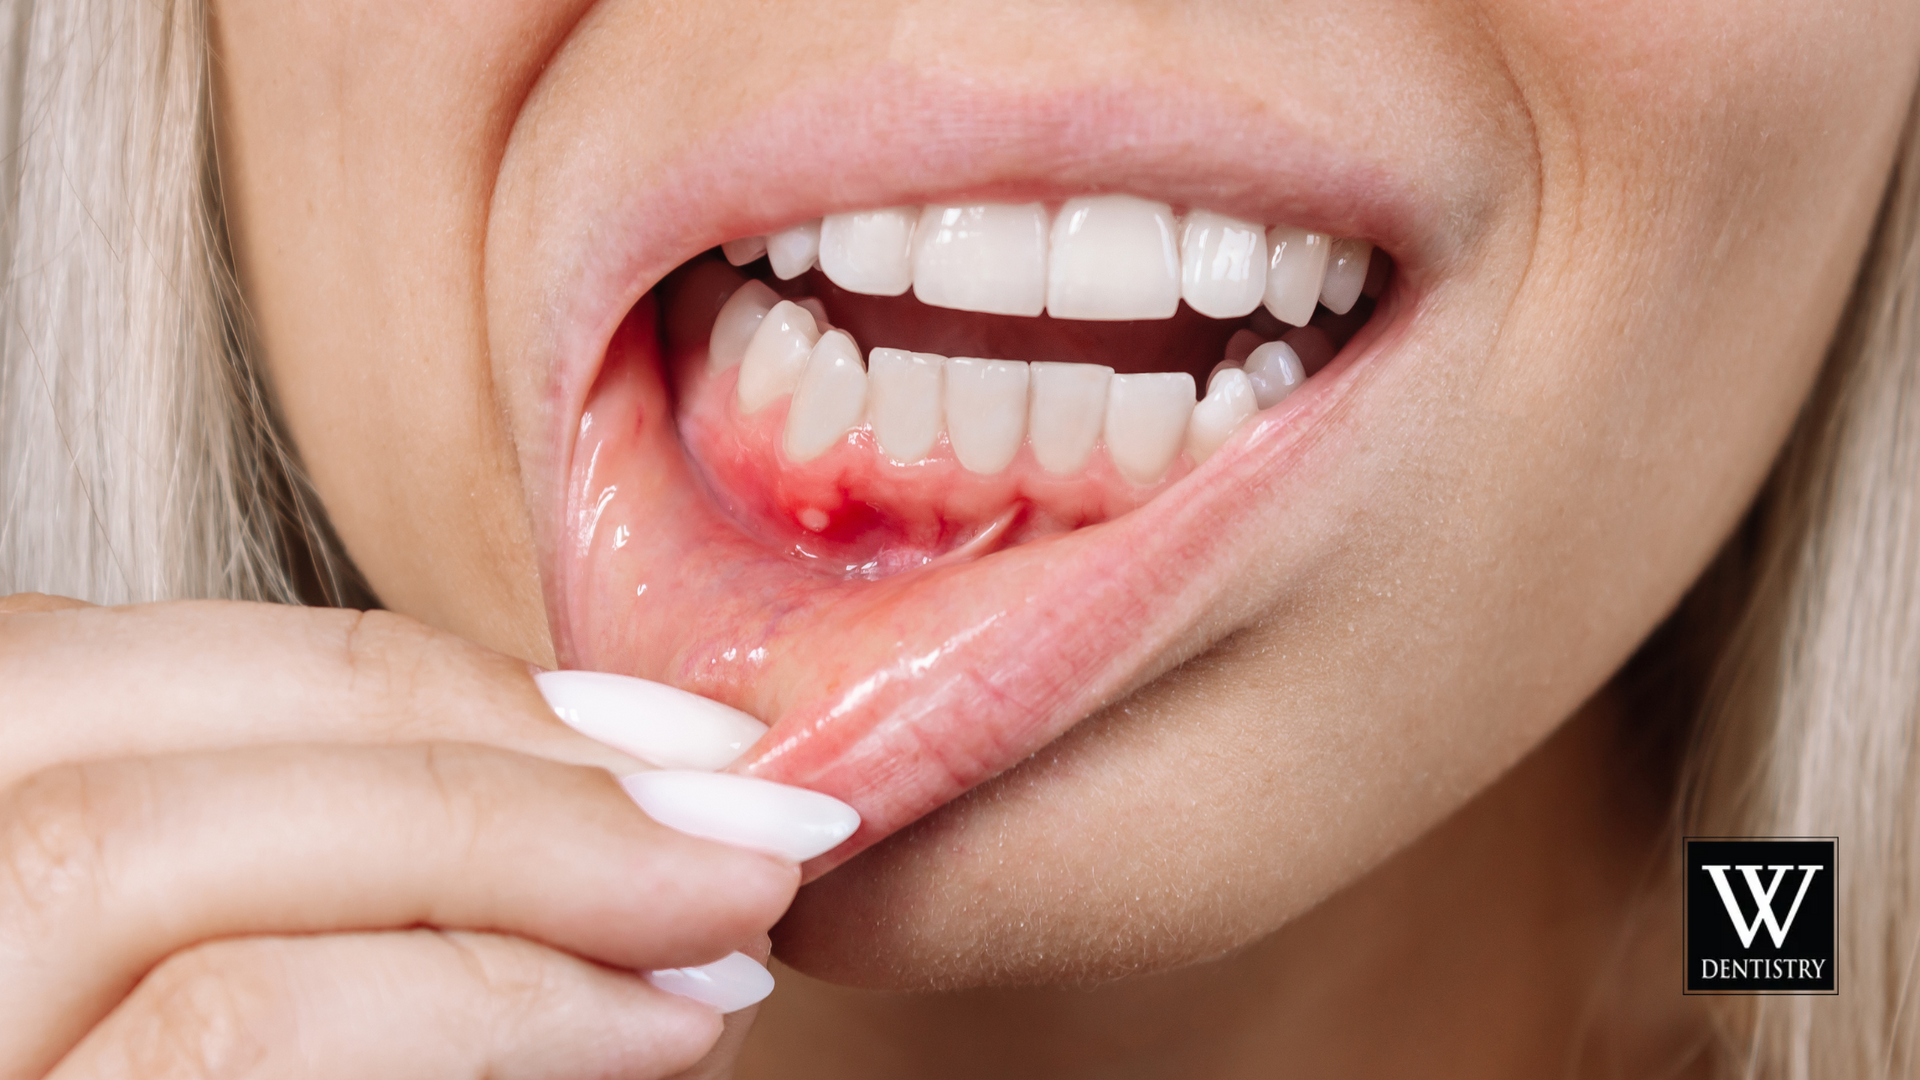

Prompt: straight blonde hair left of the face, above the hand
[0,0,292,603]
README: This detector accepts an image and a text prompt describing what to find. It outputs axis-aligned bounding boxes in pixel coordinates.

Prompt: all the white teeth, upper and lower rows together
[708,194,1373,484]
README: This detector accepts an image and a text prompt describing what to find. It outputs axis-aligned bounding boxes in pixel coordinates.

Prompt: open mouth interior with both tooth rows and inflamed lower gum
[664,194,1388,575]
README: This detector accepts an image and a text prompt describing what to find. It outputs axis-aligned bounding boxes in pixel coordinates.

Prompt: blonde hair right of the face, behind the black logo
[1684,94,1920,1080]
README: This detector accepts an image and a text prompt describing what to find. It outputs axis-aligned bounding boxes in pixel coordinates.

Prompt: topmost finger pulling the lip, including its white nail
[0,601,758,786]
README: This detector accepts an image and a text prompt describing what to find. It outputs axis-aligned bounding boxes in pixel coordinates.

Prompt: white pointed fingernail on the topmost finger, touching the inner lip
[534,671,766,769]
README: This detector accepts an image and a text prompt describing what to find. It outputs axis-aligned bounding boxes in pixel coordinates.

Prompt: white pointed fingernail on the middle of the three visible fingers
[620,771,860,863]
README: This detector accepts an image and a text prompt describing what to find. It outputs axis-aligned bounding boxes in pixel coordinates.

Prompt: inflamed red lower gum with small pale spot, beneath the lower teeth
[674,346,1192,578]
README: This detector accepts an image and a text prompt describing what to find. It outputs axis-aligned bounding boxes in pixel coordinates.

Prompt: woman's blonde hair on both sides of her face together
[0,0,1920,1078]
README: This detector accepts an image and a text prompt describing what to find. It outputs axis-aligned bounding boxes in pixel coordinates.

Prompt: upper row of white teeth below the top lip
[722,194,1373,327]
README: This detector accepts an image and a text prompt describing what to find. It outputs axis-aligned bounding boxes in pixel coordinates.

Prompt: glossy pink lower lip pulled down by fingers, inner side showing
[555,278,1413,878]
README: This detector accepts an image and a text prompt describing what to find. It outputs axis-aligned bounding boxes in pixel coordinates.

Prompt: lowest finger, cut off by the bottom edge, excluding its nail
[50,930,720,1080]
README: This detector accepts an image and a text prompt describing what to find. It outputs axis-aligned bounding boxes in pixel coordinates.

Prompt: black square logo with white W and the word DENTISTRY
[1682,836,1839,994]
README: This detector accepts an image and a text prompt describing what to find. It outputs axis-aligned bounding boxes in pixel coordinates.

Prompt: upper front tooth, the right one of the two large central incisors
[1046,194,1181,321]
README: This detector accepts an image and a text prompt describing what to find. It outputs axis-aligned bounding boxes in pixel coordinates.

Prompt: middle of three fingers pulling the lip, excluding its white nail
[0,744,794,1063]
